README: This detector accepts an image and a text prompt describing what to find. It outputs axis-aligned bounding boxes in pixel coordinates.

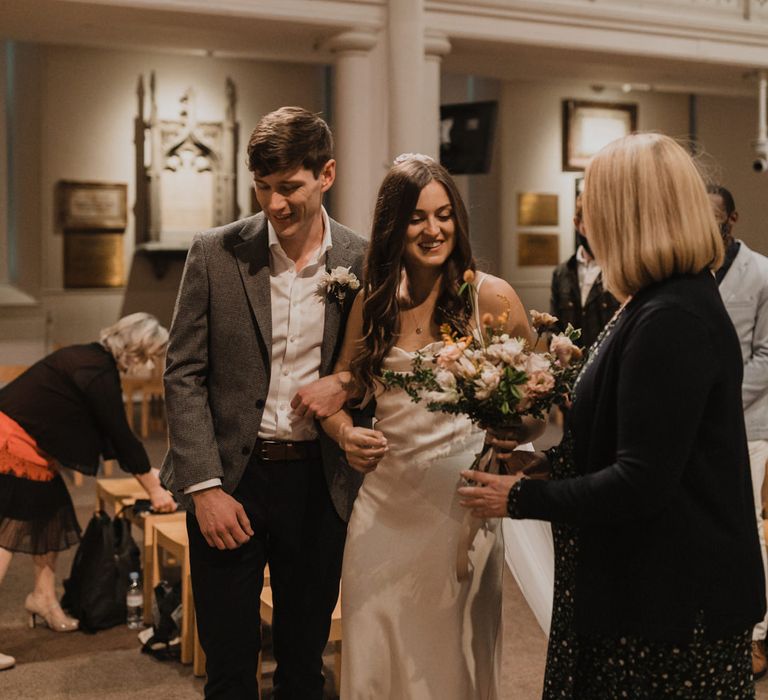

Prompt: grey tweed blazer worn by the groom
[160,214,367,520]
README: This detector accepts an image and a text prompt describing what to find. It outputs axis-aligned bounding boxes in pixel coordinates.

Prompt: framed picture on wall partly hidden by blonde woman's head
[563,100,637,172]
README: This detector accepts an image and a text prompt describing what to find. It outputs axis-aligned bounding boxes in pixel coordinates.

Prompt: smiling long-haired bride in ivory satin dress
[323,154,551,700]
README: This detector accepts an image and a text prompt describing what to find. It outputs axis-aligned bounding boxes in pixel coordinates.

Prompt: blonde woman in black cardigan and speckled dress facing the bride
[460,134,764,700]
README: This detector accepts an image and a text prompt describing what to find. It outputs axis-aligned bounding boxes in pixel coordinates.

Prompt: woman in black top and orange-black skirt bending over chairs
[0,313,176,668]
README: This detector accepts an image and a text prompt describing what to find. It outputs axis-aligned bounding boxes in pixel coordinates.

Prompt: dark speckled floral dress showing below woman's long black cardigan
[542,436,755,700]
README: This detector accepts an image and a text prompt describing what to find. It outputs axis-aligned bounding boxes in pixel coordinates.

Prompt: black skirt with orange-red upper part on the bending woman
[0,413,80,554]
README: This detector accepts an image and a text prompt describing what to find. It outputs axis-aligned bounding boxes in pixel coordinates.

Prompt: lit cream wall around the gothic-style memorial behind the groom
[0,44,324,352]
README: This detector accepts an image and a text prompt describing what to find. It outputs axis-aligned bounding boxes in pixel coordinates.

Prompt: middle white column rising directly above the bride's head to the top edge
[387,0,428,157]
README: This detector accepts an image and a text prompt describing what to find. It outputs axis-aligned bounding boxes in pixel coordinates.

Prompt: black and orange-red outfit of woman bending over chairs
[0,343,150,554]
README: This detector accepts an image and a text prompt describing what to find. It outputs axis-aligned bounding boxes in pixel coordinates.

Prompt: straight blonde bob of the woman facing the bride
[582,133,723,299]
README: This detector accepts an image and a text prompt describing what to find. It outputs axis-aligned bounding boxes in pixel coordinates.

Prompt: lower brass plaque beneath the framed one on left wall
[64,233,125,288]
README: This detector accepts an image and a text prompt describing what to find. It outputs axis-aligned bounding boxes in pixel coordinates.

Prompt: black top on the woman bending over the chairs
[0,343,150,475]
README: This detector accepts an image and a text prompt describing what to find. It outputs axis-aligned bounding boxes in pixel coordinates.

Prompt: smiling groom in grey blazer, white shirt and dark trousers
[161,107,366,700]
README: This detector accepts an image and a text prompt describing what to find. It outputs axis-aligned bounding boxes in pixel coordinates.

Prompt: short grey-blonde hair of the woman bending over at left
[99,312,168,372]
